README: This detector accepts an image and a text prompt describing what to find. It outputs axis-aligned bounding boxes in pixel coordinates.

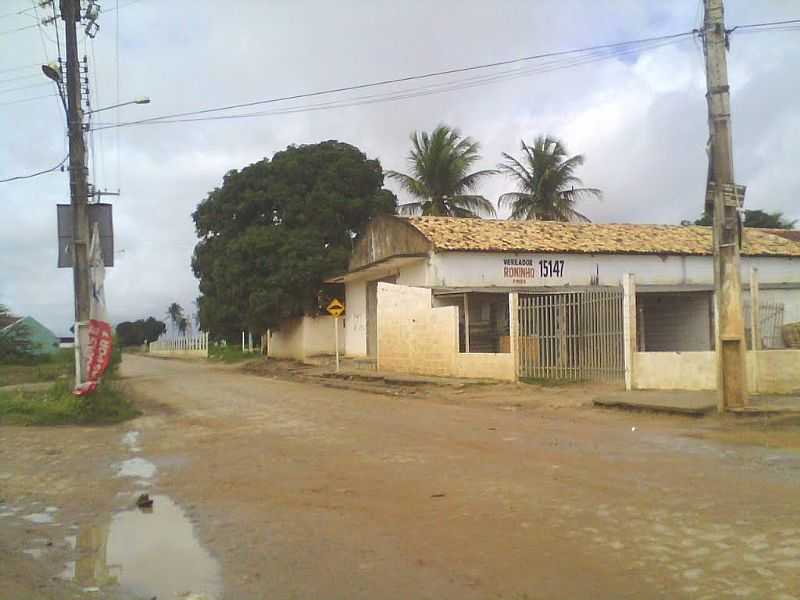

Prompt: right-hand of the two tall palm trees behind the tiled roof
[498,135,603,223]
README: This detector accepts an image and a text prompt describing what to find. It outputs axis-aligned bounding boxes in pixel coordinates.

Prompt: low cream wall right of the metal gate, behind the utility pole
[633,350,800,394]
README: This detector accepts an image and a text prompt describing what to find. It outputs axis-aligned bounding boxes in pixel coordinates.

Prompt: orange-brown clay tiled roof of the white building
[407,217,800,257]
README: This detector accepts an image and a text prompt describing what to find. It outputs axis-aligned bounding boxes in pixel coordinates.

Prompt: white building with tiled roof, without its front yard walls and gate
[330,217,800,357]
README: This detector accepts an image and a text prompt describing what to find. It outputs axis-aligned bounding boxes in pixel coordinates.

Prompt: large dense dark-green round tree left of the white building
[192,141,397,338]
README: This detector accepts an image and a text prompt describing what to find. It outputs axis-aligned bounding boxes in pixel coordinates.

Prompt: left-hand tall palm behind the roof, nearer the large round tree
[386,125,497,217]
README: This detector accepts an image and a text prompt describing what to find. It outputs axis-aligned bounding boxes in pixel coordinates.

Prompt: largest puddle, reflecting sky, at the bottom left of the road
[61,496,222,600]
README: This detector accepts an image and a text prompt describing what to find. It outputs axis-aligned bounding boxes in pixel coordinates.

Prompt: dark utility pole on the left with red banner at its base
[61,0,90,385]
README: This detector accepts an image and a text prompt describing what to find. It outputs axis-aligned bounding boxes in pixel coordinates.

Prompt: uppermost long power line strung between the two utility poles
[92,31,694,127]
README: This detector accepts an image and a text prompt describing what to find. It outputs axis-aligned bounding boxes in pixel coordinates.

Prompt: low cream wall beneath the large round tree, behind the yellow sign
[268,316,345,360]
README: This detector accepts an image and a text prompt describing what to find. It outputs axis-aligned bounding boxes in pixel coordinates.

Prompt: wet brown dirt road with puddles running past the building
[0,356,800,600]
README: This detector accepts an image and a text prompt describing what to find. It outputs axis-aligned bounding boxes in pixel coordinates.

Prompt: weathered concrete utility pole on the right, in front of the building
[703,0,748,411]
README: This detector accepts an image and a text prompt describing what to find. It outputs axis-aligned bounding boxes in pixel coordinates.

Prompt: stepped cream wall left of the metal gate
[378,283,515,381]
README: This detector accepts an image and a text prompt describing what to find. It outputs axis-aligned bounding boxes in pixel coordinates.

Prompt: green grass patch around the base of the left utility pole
[0,379,141,425]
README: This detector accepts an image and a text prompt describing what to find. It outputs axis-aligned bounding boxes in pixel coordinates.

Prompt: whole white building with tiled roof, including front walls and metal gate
[269,217,800,391]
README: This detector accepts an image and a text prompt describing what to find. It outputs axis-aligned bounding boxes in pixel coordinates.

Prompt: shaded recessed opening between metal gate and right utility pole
[636,292,712,352]
